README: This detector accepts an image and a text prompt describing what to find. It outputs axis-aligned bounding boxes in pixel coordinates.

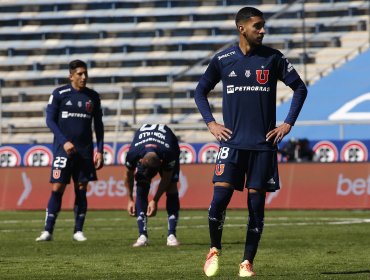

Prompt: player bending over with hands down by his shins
[124,124,180,247]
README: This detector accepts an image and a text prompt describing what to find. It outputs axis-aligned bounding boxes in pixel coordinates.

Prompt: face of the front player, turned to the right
[239,17,265,46]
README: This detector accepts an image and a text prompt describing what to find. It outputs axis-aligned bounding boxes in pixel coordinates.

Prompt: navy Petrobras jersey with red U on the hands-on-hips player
[195,45,300,151]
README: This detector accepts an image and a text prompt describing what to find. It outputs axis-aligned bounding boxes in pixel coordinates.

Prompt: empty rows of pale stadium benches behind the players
[0,0,369,143]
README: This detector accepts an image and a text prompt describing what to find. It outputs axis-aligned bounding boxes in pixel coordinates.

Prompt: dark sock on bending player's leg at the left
[135,186,149,236]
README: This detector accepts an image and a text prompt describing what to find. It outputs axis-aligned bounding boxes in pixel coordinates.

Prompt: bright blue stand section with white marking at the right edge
[277,47,370,140]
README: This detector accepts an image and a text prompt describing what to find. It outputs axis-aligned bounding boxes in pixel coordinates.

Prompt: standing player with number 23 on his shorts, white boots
[36,60,104,241]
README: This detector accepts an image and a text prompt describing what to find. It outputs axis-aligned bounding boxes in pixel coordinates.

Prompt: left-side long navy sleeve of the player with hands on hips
[194,56,221,124]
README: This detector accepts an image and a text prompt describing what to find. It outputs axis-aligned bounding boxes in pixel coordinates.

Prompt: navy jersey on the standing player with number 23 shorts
[46,84,104,158]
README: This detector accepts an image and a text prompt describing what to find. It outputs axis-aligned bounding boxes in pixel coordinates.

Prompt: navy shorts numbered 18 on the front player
[213,147,280,192]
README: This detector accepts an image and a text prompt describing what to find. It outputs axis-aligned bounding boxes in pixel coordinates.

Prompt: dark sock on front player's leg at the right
[243,192,266,263]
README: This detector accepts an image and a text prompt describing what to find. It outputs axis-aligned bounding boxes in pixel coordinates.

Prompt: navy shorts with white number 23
[50,153,97,184]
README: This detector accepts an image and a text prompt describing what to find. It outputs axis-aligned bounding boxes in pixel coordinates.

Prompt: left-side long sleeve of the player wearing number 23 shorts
[46,90,68,145]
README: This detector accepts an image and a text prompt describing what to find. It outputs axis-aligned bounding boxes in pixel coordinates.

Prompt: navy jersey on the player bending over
[126,124,180,170]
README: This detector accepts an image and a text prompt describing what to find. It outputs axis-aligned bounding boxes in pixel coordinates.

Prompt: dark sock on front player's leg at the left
[208,187,234,249]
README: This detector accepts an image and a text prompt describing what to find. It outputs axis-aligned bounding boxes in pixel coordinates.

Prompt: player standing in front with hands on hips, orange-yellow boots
[195,7,307,277]
